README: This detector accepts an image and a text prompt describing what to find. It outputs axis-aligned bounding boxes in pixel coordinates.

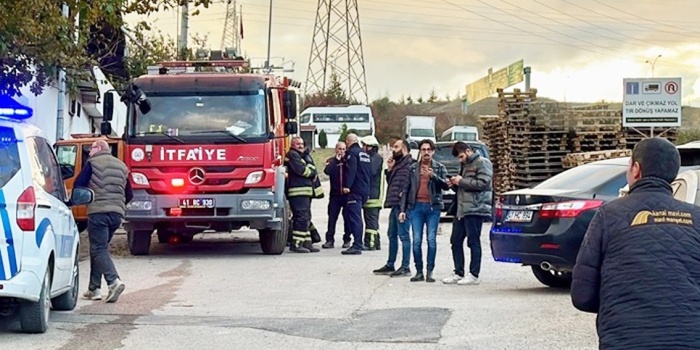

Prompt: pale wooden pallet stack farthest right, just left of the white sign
[567,104,626,152]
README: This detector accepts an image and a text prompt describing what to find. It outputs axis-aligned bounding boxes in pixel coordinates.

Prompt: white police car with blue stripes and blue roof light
[0,95,93,333]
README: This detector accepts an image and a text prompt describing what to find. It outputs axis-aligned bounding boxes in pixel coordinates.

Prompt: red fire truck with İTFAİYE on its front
[101,55,299,255]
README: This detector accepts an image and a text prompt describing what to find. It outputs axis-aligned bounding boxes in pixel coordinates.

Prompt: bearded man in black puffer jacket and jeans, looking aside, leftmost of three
[373,140,413,277]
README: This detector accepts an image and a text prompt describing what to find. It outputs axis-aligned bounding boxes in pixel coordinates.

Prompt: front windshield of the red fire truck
[130,90,267,139]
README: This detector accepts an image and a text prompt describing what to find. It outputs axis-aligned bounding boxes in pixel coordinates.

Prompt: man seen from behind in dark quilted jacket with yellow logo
[571,138,700,349]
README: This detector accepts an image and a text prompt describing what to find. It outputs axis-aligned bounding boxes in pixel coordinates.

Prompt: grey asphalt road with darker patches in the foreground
[0,180,597,350]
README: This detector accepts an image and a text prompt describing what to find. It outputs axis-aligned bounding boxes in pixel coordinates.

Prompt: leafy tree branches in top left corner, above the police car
[0,0,212,95]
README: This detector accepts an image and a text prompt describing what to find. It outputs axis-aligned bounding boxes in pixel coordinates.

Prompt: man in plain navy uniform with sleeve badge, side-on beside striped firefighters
[343,134,371,255]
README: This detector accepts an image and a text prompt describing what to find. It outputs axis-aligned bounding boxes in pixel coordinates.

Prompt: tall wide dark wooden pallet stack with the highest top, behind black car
[499,89,568,188]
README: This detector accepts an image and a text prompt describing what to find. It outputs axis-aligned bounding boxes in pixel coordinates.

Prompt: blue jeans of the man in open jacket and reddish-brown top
[411,203,440,272]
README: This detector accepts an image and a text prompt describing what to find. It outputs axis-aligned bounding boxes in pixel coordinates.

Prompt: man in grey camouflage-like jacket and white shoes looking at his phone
[442,142,493,285]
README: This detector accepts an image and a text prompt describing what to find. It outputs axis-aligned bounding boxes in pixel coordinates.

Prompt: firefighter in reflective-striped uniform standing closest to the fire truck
[284,137,318,253]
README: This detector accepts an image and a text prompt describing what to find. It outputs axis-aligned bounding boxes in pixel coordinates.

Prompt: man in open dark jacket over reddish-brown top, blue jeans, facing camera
[407,139,450,282]
